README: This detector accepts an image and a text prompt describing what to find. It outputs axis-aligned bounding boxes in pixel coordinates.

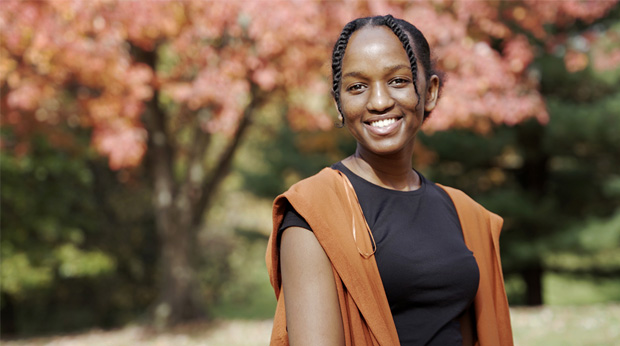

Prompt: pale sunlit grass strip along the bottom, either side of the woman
[2,304,620,346]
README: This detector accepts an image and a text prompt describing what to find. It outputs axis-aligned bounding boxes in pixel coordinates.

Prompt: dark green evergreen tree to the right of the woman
[416,5,620,305]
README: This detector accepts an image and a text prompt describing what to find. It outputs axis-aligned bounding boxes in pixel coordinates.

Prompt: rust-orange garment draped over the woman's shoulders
[266,168,513,346]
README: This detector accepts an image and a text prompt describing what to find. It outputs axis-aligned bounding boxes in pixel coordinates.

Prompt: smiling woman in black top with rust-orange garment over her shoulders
[267,15,512,345]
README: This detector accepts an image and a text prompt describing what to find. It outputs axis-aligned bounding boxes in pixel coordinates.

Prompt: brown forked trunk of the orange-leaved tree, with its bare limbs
[132,47,263,326]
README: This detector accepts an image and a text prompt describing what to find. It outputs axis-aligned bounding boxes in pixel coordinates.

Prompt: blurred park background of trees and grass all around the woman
[0,0,620,345]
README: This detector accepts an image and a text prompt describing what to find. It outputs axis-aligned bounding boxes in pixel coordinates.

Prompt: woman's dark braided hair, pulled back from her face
[332,14,442,126]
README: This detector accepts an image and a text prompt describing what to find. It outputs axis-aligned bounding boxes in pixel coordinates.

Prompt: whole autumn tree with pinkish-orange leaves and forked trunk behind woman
[0,0,615,323]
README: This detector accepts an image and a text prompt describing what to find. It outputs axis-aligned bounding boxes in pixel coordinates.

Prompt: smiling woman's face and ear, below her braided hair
[340,26,438,155]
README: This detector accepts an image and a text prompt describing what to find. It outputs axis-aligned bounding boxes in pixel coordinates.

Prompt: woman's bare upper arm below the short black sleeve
[280,227,344,345]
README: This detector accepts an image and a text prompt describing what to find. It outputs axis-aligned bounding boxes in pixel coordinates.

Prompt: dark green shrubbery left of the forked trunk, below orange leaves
[0,133,157,335]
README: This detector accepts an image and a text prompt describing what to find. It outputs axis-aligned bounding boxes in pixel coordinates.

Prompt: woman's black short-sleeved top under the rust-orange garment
[279,162,479,345]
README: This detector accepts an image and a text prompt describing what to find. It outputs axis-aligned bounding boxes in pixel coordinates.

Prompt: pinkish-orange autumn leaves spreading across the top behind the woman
[0,0,619,169]
